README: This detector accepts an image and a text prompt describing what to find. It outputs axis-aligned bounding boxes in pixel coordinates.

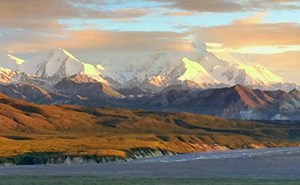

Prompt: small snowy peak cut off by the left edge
[0,53,24,71]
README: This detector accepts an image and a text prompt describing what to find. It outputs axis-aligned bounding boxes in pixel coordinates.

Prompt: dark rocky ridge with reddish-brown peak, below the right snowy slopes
[144,85,300,120]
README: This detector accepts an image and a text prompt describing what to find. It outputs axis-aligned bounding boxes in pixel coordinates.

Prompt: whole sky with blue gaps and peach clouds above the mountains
[0,0,300,83]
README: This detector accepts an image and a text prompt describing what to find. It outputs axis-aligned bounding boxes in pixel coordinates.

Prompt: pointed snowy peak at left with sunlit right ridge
[20,48,108,84]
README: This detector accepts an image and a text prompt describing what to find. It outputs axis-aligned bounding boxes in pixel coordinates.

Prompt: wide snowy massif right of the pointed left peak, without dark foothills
[99,45,297,91]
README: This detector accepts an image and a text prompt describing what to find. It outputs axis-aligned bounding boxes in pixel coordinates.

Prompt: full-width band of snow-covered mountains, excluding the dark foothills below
[0,44,297,92]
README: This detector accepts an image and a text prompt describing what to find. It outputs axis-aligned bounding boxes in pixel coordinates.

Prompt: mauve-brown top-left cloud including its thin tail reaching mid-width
[0,0,151,31]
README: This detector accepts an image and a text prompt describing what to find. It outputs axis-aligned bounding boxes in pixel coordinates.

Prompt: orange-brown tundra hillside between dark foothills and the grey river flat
[0,94,300,164]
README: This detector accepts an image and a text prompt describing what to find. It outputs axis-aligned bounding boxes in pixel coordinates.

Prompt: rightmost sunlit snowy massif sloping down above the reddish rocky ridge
[199,49,286,90]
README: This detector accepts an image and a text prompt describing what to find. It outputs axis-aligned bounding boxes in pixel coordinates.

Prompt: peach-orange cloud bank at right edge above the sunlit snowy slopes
[193,21,300,49]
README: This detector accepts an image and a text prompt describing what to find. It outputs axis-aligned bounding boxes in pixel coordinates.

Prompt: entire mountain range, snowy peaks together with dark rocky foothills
[0,47,300,120]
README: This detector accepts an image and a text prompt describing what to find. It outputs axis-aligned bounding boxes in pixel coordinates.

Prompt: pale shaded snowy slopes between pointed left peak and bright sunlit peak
[102,53,183,84]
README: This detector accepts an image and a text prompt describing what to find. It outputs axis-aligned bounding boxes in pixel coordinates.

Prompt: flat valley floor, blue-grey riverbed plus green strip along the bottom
[0,147,300,185]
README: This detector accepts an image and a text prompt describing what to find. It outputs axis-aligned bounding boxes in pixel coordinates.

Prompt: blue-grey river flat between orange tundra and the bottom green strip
[0,148,300,178]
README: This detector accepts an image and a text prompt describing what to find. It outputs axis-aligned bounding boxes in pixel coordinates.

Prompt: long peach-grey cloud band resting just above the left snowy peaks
[2,30,193,53]
